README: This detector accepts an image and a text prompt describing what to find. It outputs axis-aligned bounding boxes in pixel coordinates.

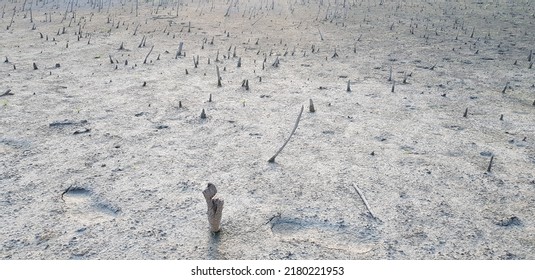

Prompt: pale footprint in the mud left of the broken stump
[61,186,121,225]
